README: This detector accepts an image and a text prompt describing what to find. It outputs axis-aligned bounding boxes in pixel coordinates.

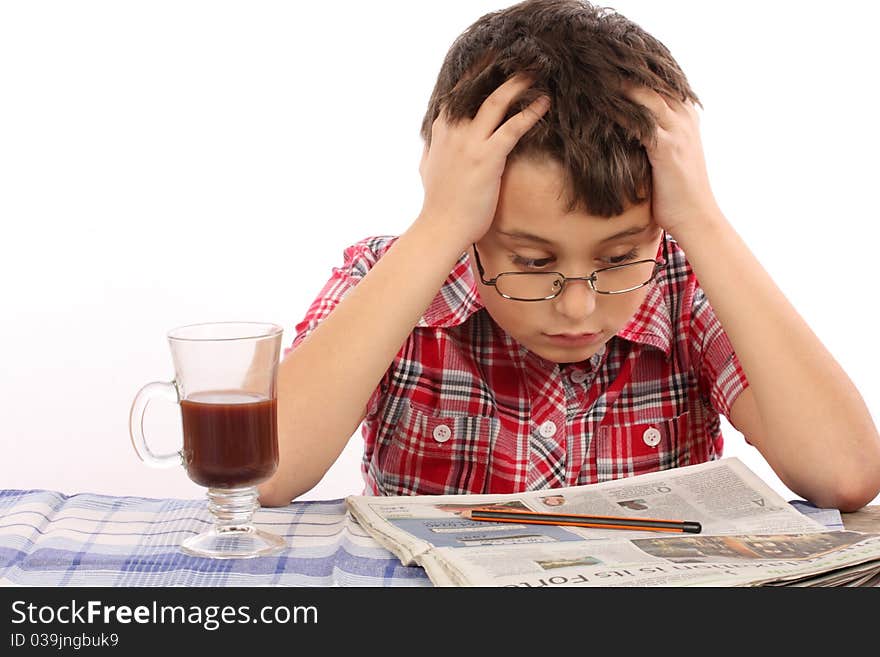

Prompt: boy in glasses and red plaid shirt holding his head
[260,0,880,511]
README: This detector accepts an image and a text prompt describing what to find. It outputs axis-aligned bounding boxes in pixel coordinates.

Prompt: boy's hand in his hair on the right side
[623,84,719,236]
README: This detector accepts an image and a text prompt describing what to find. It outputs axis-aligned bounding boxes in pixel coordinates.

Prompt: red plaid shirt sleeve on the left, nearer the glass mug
[284,236,396,416]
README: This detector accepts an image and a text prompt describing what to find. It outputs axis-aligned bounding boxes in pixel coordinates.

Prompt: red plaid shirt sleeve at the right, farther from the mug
[690,287,749,420]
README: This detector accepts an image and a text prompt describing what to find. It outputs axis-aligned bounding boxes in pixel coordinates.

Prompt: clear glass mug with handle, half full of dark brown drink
[129,322,286,559]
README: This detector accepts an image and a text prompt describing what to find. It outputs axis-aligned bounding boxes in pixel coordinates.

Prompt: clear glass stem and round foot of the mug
[181,486,287,559]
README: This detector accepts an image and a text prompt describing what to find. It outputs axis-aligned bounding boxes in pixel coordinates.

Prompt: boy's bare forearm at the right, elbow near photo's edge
[675,211,880,500]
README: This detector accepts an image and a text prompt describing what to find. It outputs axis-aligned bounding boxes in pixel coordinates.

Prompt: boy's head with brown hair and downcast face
[421,0,699,363]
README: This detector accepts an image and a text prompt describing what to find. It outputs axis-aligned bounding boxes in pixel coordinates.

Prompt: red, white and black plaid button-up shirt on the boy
[285,236,748,495]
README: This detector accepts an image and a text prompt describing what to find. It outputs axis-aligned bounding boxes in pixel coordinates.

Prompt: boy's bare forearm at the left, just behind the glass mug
[259,217,468,506]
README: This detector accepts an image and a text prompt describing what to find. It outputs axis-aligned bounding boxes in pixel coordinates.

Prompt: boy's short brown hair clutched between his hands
[421,0,702,217]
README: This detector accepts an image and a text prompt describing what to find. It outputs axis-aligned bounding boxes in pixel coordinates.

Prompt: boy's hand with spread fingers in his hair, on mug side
[419,74,550,248]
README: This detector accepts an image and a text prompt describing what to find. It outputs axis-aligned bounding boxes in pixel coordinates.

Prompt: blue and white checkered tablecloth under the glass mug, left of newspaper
[0,490,431,586]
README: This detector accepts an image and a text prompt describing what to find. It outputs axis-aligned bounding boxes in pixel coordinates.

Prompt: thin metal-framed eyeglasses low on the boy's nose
[473,231,666,301]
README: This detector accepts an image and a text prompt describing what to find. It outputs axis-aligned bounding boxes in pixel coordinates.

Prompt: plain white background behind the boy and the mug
[0,0,880,498]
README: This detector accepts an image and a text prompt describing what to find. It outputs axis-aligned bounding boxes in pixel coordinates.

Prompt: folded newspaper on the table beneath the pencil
[346,457,880,587]
